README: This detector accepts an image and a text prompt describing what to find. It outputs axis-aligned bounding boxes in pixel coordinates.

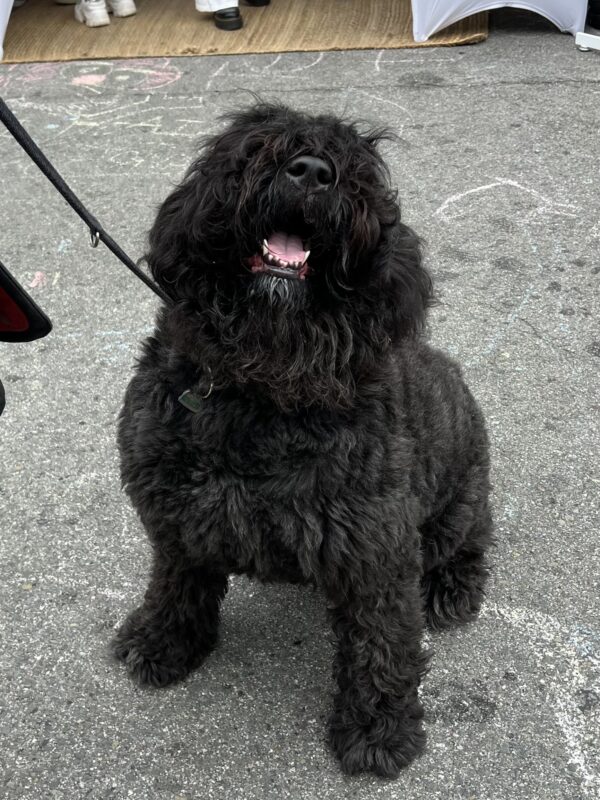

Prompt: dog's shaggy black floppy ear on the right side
[372,218,433,342]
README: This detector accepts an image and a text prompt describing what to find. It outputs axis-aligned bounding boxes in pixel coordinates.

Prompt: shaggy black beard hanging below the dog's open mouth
[165,275,372,411]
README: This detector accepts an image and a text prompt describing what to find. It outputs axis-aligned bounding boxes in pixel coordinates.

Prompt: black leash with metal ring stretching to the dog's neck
[0,97,173,305]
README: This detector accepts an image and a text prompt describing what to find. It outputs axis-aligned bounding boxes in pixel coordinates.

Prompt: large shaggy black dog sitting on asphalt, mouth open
[114,105,491,777]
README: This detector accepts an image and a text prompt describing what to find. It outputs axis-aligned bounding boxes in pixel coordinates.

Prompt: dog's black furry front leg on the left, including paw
[113,548,227,686]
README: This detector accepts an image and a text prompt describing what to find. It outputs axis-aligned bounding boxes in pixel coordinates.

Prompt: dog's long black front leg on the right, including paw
[327,540,427,778]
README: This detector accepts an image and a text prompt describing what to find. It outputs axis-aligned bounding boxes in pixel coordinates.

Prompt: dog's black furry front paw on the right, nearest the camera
[329,714,425,778]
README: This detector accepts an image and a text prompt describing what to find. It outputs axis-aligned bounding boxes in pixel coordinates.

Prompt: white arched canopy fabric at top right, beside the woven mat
[412,0,587,42]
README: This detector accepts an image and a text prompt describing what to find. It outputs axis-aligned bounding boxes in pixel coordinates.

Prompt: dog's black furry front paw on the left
[112,607,202,687]
